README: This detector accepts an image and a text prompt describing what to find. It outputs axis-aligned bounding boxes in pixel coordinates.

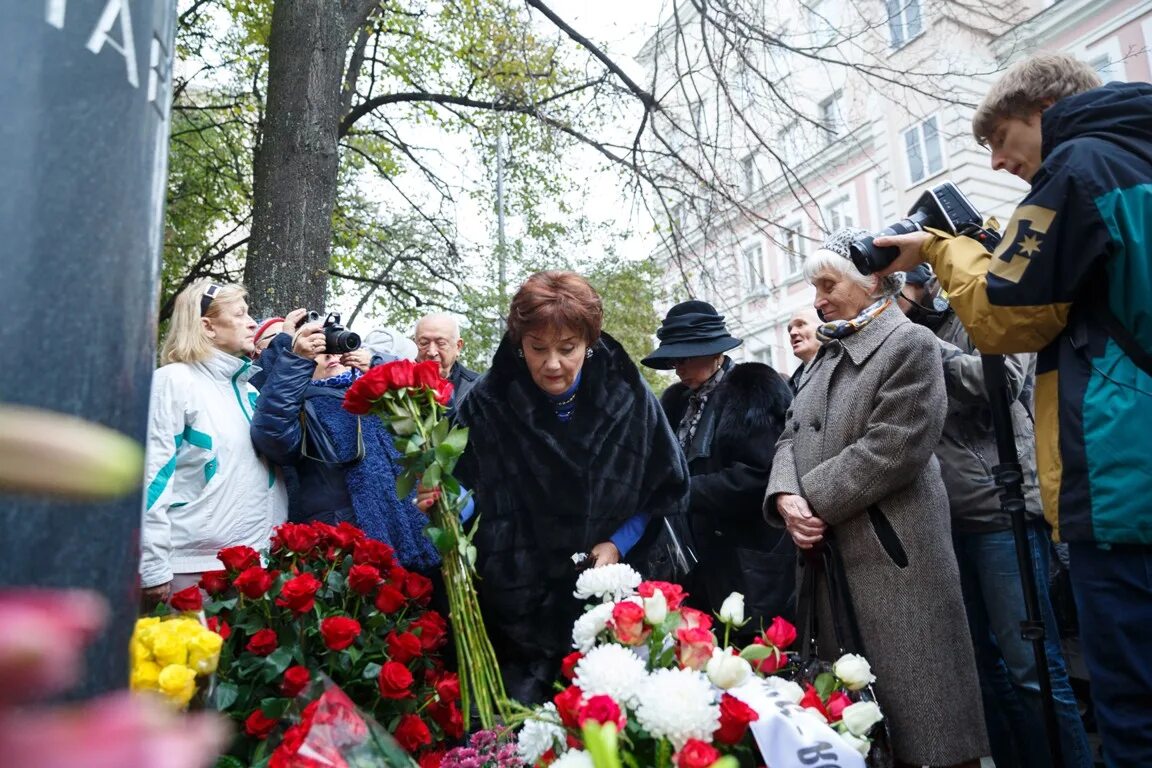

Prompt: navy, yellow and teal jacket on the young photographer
[924,83,1152,545]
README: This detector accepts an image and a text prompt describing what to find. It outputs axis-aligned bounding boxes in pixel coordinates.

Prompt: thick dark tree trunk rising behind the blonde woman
[244,0,348,317]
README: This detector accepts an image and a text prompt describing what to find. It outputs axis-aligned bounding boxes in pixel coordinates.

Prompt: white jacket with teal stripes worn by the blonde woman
[141,351,288,588]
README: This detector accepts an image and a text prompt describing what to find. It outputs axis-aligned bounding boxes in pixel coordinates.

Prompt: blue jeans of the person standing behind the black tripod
[953,522,1092,768]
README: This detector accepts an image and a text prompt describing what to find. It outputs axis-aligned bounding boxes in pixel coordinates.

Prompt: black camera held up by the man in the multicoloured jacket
[848,181,1000,275]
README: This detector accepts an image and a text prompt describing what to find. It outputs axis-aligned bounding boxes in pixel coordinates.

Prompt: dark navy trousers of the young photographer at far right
[1069,542,1152,768]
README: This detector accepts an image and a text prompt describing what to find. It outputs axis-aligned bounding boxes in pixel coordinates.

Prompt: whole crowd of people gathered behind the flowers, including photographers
[141,55,1152,768]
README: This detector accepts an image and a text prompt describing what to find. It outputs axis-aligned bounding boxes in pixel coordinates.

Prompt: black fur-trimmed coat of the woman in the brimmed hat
[660,358,796,633]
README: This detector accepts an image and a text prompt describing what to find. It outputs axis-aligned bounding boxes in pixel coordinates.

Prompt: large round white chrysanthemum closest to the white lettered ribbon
[636,669,720,750]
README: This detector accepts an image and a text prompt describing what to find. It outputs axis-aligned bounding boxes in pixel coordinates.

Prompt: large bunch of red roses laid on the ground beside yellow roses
[200,523,464,765]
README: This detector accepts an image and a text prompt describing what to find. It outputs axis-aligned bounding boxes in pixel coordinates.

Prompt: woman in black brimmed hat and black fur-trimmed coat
[642,301,796,632]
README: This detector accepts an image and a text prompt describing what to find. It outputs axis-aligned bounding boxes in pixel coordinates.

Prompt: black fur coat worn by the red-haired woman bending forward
[456,334,688,702]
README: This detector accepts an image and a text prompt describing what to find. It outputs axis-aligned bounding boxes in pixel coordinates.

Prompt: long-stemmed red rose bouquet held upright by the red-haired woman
[344,360,507,728]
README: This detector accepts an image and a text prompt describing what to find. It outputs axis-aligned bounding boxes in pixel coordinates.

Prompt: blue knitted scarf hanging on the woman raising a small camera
[310,396,440,571]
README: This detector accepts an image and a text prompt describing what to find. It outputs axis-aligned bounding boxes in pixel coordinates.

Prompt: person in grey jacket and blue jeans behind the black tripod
[897,264,1092,768]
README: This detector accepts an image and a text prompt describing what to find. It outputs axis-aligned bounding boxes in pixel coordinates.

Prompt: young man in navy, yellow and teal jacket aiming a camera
[874,54,1152,767]
